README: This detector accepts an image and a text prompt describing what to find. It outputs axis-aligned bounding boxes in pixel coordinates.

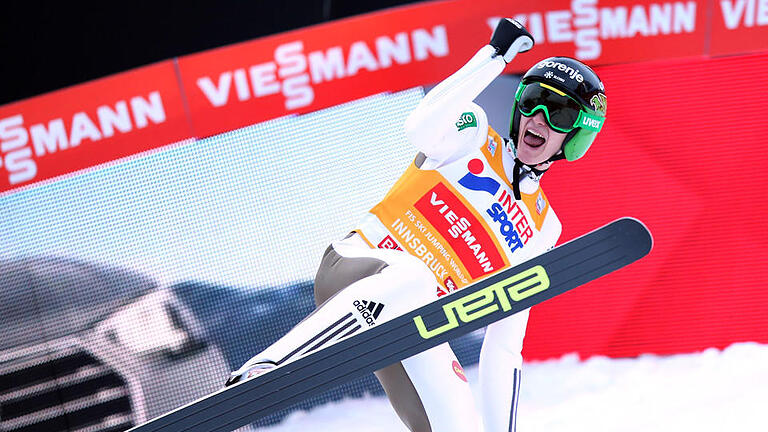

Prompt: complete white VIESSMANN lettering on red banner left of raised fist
[196,25,449,110]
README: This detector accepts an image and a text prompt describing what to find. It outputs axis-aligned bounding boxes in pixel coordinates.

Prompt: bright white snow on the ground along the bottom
[252,343,768,432]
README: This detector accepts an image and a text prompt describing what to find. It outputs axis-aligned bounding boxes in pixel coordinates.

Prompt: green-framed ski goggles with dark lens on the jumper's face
[515,82,605,132]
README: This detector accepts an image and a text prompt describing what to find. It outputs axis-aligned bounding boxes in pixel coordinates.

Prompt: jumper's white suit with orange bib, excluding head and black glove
[243,46,561,432]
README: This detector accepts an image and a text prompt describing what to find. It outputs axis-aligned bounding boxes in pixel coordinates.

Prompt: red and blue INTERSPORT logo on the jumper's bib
[459,159,533,252]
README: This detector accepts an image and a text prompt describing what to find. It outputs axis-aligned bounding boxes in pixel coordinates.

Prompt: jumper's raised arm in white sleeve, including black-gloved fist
[405,18,533,161]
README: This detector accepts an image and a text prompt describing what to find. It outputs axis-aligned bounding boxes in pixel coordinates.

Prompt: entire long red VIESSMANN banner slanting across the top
[0,0,768,193]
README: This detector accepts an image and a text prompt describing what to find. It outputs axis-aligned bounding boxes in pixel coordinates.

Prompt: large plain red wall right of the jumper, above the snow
[525,54,768,359]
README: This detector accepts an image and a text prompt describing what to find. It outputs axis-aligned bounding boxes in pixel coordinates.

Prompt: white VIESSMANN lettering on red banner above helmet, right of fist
[487,0,697,60]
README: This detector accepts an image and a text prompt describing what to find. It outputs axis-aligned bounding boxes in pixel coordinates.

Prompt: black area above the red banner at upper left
[0,0,426,104]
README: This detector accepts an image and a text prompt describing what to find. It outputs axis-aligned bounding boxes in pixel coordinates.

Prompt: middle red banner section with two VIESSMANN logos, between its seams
[174,0,706,136]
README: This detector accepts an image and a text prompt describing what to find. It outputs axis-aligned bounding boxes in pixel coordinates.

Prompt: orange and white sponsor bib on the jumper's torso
[356,128,549,295]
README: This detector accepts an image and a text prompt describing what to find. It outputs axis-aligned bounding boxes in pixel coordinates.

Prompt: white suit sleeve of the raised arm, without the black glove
[405,45,506,162]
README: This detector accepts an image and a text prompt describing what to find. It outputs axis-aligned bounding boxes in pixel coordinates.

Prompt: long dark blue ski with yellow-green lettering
[130,218,653,432]
